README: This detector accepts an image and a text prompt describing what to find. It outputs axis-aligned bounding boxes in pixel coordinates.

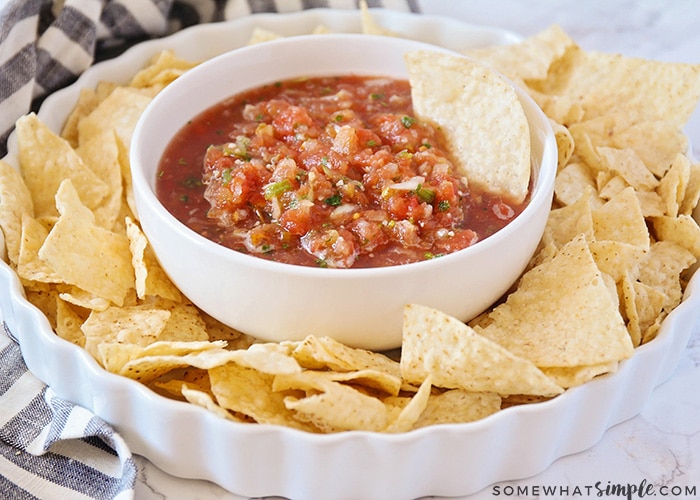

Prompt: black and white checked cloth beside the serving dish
[0,0,419,500]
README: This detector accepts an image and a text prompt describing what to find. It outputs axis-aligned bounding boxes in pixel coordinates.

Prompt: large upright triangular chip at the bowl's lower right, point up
[477,236,634,367]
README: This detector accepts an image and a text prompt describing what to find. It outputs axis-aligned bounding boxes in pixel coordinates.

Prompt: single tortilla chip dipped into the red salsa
[404,50,530,203]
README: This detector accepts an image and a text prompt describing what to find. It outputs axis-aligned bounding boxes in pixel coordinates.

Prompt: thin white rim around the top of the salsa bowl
[129,33,557,280]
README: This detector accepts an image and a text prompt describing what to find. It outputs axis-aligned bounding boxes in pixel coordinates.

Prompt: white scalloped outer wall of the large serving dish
[0,9,700,499]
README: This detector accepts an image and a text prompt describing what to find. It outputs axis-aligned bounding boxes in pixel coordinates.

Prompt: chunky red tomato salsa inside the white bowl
[157,76,524,268]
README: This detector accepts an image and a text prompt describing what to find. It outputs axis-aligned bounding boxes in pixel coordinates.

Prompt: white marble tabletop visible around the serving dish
[136,0,700,500]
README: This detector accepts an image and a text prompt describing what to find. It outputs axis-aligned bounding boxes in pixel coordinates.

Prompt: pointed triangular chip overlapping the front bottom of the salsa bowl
[401,304,562,396]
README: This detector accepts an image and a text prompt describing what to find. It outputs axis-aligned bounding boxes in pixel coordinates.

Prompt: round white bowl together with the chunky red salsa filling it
[130,35,557,350]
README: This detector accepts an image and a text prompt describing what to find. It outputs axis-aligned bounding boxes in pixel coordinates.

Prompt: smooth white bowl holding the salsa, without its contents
[131,34,557,350]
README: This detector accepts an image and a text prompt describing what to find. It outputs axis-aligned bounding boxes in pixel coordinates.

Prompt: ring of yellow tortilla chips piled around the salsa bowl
[0,12,700,433]
